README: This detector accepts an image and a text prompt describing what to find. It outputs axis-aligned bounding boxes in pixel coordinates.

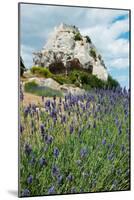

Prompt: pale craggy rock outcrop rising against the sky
[33,24,108,80]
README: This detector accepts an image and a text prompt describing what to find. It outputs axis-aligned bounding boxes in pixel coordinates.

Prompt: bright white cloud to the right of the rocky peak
[81,16,129,69]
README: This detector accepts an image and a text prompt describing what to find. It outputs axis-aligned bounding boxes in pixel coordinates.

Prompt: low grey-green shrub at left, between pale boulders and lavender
[24,81,62,97]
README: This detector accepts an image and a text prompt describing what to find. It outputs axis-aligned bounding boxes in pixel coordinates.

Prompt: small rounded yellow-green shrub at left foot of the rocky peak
[30,66,52,78]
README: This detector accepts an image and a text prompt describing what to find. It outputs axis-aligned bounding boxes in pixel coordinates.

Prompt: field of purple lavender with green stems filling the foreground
[19,88,130,196]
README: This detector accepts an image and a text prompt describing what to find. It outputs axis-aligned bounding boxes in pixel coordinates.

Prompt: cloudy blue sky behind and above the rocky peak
[20,4,129,88]
